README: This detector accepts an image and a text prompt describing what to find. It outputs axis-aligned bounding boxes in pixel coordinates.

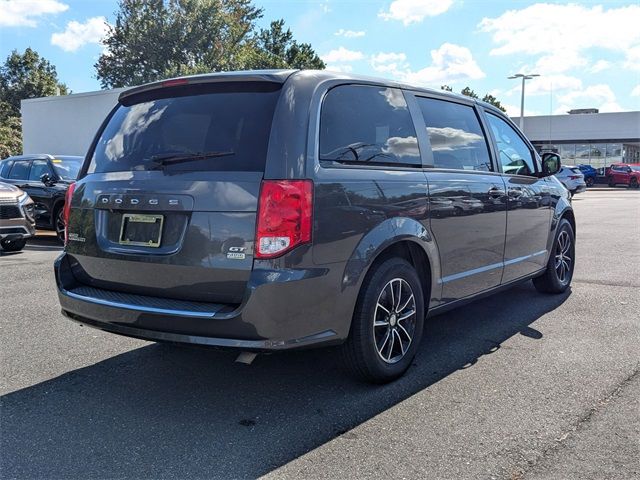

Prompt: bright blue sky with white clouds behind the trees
[0,0,640,115]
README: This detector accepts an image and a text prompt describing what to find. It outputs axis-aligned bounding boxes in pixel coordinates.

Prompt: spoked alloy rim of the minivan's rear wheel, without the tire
[373,278,416,363]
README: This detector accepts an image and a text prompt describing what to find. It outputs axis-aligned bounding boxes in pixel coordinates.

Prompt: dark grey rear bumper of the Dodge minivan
[54,253,351,351]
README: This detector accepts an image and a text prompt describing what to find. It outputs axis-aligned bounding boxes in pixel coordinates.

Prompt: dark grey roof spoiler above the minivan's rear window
[118,70,297,103]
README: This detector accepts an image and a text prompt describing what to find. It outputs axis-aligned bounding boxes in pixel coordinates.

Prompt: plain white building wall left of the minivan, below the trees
[20,89,124,156]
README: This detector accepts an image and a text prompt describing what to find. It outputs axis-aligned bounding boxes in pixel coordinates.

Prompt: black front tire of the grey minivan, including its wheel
[533,218,576,293]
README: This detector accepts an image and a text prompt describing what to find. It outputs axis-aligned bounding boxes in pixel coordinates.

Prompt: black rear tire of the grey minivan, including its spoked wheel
[342,258,425,383]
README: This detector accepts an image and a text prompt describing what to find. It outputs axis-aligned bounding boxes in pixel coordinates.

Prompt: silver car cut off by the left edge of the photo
[0,182,36,252]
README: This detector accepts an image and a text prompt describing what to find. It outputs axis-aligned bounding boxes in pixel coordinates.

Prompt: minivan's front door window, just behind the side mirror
[487,113,536,175]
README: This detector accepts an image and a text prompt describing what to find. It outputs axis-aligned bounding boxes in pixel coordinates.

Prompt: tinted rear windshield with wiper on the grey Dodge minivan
[87,82,280,173]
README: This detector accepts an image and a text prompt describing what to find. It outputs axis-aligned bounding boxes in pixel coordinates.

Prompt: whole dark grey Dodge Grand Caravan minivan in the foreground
[55,71,575,382]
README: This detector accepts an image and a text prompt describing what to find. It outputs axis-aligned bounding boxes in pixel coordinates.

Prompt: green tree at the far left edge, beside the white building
[0,48,68,158]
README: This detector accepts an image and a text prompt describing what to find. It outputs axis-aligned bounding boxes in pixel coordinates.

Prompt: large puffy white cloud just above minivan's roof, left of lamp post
[402,43,485,87]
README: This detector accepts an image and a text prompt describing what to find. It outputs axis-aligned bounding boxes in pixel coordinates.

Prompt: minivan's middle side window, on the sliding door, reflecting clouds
[418,98,492,172]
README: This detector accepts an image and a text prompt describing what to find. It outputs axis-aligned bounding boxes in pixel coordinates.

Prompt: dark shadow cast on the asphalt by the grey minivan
[0,283,570,478]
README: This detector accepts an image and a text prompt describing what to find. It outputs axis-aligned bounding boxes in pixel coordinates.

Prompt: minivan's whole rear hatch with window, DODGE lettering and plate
[67,80,281,304]
